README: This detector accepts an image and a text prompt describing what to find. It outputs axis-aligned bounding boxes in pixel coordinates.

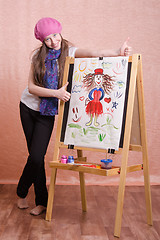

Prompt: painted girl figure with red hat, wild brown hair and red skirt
[83,68,114,127]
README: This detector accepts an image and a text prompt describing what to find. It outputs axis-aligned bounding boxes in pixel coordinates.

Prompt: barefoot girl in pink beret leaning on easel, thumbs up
[17,18,131,215]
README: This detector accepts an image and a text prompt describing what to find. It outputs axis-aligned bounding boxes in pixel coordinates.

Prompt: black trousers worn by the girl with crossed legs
[17,102,55,207]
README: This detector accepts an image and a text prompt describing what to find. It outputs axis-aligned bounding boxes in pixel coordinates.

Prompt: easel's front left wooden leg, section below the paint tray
[46,168,57,221]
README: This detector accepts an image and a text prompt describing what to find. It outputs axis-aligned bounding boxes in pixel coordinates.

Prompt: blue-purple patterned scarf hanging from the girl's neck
[40,49,61,116]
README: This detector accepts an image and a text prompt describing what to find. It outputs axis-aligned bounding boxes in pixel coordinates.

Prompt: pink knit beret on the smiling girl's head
[34,18,62,42]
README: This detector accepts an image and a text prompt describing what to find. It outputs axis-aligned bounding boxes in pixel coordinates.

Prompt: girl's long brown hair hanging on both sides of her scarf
[32,36,69,88]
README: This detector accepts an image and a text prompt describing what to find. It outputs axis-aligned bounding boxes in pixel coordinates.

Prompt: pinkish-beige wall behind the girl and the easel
[0,0,160,184]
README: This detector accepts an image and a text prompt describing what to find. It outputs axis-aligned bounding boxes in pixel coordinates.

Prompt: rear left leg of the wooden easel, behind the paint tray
[77,150,87,212]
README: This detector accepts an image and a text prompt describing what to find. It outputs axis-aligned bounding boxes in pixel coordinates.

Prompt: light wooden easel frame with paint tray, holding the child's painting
[46,54,152,237]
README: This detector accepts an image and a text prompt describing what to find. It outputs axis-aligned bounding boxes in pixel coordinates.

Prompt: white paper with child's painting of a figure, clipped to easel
[64,57,128,150]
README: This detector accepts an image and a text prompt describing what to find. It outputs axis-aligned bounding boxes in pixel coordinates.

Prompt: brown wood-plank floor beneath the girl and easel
[0,185,160,240]
